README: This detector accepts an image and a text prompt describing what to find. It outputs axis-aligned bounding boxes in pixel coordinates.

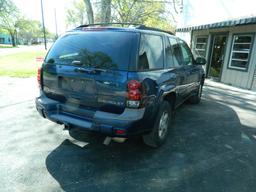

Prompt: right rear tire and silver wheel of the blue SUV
[142,101,172,148]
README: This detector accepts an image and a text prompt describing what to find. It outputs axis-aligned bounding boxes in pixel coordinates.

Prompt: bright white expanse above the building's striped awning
[179,0,256,26]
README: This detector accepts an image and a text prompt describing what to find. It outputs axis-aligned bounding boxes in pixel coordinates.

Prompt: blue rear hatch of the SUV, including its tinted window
[42,29,138,113]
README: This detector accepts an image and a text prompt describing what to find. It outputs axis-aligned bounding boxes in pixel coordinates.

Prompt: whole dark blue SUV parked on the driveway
[36,25,206,147]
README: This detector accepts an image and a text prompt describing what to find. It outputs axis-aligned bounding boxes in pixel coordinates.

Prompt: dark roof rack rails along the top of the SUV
[77,23,174,35]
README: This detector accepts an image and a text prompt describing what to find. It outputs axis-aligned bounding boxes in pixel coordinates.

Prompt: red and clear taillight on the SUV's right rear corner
[127,80,142,108]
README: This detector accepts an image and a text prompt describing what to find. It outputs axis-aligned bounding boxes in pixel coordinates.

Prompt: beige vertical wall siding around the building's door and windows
[185,24,256,90]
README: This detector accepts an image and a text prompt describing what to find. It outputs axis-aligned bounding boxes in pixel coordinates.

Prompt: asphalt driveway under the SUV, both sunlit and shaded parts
[0,78,256,192]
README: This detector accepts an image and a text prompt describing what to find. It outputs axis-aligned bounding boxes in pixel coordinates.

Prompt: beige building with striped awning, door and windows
[176,17,256,90]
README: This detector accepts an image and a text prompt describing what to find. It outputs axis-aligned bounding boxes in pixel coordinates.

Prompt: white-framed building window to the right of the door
[229,34,253,70]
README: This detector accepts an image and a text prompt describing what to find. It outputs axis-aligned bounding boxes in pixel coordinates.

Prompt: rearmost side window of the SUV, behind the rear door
[138,34,164,70]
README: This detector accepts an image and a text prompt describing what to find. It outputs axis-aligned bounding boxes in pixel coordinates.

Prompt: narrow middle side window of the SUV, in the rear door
[169,37,184,67]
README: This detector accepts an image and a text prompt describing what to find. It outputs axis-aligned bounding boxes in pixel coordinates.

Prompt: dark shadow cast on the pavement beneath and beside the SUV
[46,99,256,192]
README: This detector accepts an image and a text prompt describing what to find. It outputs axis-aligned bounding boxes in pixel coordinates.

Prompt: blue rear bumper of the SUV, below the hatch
[36,95,146,137]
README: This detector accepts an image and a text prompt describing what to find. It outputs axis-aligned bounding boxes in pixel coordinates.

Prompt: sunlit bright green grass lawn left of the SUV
[0,51,46,77]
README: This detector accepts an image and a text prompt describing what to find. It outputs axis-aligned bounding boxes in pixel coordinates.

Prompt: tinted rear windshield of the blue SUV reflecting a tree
[45,31,135,70]
